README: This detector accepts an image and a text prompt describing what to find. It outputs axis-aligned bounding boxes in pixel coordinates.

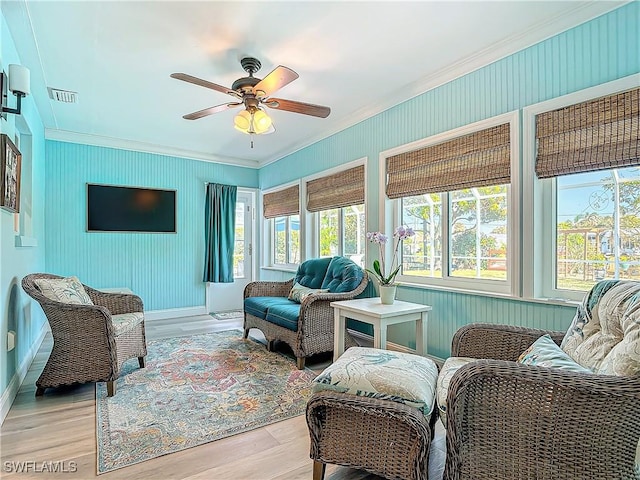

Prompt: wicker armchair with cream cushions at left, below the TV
[22,273,147,396]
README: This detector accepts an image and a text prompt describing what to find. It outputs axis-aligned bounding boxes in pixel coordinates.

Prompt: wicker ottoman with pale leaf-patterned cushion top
[307,347,438,480]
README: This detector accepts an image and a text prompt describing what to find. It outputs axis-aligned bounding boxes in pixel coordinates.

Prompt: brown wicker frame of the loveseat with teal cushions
[244,257,369,369]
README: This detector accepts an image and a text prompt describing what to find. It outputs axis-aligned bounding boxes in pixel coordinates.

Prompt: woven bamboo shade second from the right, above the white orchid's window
[386,123,511,198]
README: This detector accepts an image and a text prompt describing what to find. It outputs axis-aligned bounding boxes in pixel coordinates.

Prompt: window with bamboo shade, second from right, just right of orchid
[386,114,518,293]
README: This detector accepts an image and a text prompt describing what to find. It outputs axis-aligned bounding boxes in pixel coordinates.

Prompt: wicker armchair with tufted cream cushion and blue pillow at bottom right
[437,280,640,480]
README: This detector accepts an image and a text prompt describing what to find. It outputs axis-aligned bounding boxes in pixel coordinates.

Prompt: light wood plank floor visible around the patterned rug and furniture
[0,315,444,480]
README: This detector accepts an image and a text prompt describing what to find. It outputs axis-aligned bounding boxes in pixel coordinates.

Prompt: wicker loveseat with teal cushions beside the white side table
[244,257,368,369]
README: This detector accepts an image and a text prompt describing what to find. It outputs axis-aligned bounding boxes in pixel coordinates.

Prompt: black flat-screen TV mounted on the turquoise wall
[87,183,176,233]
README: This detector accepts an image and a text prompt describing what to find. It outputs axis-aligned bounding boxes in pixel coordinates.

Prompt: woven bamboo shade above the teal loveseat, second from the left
[307,165,364,212]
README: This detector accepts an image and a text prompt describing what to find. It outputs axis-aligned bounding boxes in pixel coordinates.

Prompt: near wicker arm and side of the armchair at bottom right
[445,360,640,480]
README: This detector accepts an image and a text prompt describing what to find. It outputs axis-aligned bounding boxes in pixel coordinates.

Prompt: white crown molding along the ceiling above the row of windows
[254,0,632,168]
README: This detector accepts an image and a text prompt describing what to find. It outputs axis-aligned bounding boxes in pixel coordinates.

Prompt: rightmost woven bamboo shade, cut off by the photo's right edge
[536,88,640,178]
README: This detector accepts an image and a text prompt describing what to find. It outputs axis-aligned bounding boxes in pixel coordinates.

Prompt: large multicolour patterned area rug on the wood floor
[96,330,315,474]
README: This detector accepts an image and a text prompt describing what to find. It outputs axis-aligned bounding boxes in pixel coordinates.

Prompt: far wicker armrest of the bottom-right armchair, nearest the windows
[451,323,565,362]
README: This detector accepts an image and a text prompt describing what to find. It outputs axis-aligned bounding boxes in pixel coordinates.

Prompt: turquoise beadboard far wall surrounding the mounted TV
[45,140,258,310]
